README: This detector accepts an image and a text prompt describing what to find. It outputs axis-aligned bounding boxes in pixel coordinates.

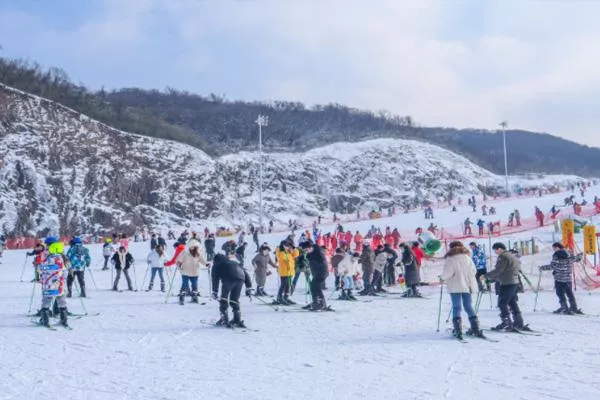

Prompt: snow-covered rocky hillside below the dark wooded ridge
[0,85,578,234]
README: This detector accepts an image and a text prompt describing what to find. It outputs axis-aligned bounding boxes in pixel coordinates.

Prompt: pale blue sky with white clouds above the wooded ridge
[0,0,600,147]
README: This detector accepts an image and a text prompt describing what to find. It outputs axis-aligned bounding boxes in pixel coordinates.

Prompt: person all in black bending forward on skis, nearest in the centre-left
[212,249,253,328]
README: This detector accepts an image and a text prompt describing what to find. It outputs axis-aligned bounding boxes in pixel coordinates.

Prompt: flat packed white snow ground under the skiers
[0,188,600,400]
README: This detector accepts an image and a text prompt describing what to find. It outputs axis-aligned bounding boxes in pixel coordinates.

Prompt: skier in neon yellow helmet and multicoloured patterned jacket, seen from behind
[39,236,69,327]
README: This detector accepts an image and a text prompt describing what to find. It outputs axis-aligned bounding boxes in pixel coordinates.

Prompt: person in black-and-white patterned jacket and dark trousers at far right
[540,242,583,314]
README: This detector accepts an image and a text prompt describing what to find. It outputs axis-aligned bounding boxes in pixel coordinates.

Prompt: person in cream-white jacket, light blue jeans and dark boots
[440,241,483,339]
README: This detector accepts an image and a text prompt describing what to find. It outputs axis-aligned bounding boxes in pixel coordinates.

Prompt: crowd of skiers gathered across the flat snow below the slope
[21,214,581,340]
